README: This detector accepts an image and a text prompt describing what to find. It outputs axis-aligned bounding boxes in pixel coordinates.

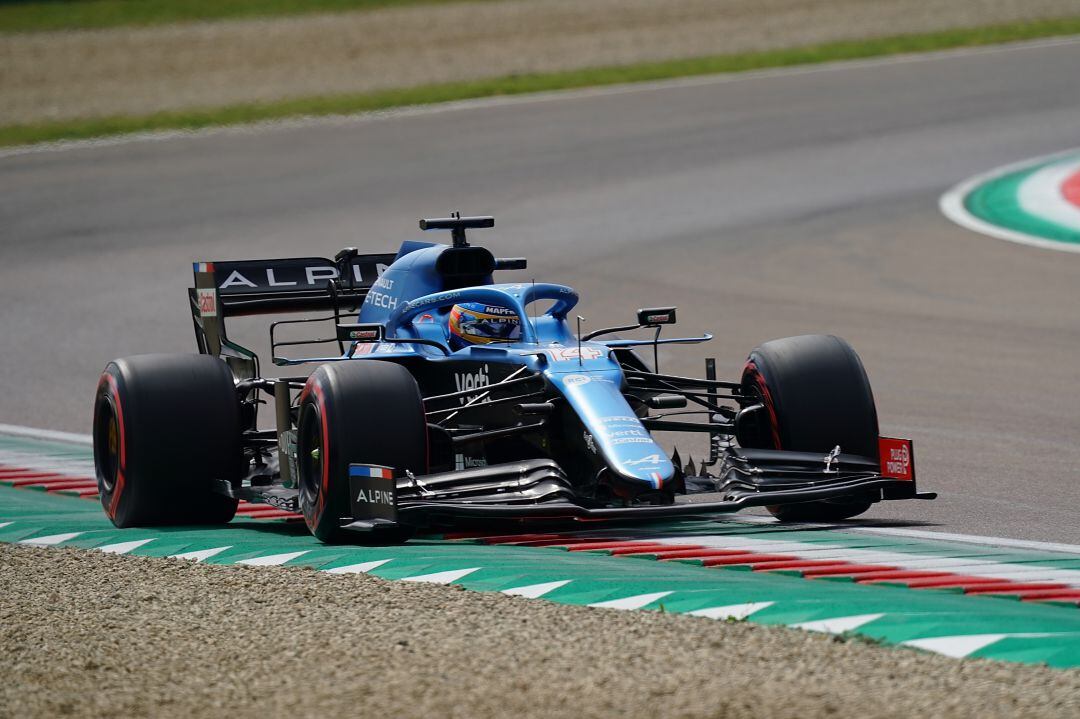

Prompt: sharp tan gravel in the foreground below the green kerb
[0,545,1080,719]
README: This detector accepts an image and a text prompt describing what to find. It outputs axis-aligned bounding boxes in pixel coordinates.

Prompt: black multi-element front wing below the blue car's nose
[341,448,936,531]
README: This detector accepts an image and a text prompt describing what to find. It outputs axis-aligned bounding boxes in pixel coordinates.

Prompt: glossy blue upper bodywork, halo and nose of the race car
[307,242,675,489]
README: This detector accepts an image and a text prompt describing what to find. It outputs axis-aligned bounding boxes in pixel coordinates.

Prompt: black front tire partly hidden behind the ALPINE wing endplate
[296,360,428,542]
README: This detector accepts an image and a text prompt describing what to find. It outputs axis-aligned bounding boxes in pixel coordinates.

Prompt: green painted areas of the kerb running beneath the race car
[0,437,1080,667]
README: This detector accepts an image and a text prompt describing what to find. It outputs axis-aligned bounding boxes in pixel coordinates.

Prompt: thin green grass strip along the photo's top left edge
[0,0,486,32]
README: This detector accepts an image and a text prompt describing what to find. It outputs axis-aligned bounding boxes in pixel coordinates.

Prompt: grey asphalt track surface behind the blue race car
[0,41,1080,543]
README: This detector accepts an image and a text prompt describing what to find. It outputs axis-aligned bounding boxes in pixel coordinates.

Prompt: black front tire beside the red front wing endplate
[740,335,878,521]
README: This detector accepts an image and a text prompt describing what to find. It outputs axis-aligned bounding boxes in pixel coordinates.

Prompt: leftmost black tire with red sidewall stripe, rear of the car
[94,354,244,527]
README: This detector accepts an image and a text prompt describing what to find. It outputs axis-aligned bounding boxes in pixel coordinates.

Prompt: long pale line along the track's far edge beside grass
[0,37,1080,159]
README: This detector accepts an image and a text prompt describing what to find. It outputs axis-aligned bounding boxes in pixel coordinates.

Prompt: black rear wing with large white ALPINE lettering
[188,247,396,379]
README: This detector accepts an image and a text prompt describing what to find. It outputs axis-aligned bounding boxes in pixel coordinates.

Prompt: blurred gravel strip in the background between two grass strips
[0,0,1078,125]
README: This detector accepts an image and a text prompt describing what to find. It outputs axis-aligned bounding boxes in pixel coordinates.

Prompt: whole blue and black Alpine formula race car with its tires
[94,214,934,541]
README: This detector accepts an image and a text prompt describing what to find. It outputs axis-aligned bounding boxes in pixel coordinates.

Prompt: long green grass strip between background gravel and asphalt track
[0,17,1080,147]
